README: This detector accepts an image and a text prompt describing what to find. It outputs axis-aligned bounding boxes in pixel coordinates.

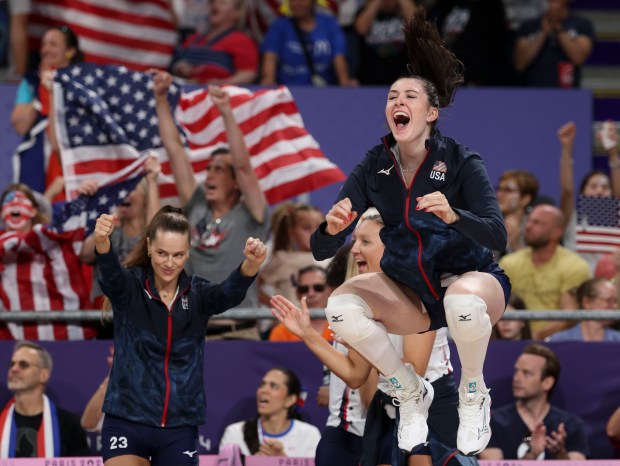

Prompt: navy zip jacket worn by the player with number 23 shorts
[97,251,254,427]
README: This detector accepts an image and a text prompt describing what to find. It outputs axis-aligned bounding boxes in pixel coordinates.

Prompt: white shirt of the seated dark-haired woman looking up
[220,419,321,458]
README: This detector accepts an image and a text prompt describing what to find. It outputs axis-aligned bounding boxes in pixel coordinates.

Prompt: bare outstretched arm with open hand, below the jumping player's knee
[271,295,372,388]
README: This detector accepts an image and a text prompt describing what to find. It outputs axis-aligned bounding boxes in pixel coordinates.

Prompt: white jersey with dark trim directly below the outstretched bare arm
[327,341,366,437]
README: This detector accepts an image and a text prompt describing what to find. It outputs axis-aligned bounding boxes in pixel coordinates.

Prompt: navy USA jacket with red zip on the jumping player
[310,132,507,303]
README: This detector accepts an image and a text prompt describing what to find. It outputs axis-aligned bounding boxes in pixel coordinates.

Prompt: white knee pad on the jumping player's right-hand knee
[443,294,491,342]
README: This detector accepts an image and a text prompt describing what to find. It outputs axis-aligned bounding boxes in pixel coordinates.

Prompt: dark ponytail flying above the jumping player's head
[405,5,464,108]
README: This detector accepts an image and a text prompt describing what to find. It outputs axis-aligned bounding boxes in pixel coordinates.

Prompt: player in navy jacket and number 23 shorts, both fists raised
[94,206,267,466]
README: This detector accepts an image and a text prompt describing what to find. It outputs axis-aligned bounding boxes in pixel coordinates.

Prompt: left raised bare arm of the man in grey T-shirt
[153,71,198,205]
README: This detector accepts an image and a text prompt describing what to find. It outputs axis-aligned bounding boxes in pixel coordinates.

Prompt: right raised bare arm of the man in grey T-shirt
[209,86,267,223]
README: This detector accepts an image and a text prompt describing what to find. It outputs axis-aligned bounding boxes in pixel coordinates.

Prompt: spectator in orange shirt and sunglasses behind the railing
[269,265,333,341]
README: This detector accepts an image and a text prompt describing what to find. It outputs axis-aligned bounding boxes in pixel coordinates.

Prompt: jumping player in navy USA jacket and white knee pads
[311,7,510,455]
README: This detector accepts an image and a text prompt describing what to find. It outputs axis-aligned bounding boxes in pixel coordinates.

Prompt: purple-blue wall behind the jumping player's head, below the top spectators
[0,84,592,211]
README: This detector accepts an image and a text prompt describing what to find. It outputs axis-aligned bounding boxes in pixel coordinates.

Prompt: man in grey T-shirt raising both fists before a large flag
[153,71,269,339]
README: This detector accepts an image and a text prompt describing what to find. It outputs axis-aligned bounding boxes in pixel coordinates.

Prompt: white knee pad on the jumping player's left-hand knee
[325,294,377,343]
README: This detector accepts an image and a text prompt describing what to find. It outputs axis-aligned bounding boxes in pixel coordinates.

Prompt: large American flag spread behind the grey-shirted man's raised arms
[54,64,344,204]
